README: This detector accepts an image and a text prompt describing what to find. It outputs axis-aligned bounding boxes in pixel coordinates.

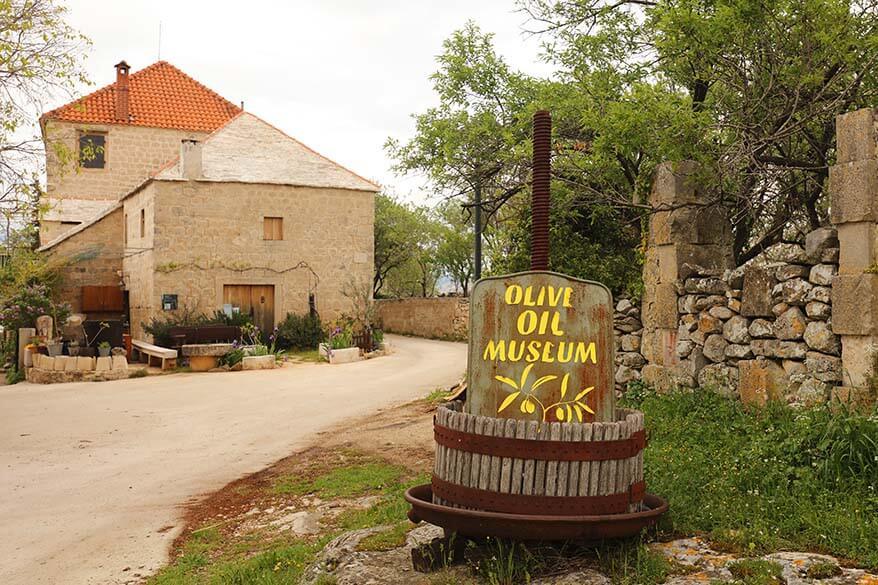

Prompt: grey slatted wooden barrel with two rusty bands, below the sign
[432,402,646,516]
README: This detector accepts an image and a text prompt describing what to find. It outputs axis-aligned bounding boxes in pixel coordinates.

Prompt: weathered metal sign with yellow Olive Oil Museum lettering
[466,272,615,422]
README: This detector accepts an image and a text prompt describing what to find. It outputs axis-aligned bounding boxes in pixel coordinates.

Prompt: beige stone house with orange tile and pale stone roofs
[40,62,378,339]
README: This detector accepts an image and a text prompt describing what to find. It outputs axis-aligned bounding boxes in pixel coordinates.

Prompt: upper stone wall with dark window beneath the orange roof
[40,119,207,245]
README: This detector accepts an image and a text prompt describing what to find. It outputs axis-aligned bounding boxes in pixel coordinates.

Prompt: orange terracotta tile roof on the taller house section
[42,61,241,132]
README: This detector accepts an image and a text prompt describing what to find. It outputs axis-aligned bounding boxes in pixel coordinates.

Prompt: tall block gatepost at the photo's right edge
[829,108,878,399]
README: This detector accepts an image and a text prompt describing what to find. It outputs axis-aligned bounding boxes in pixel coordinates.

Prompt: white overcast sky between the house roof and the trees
[51,0,546,201]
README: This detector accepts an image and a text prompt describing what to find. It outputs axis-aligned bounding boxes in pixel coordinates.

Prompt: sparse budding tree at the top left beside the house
[0,0,88,241]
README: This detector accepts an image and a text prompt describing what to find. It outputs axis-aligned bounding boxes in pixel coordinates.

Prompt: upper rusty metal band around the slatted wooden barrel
[433,421,646,461]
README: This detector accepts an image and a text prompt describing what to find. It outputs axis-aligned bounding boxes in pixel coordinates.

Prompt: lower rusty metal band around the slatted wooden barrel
[432,475,646,516]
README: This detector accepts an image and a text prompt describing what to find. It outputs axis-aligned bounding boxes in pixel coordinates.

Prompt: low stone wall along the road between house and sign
[376,297,469,341]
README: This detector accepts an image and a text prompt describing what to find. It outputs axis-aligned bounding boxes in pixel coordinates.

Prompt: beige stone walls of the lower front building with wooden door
[123,180,374,339]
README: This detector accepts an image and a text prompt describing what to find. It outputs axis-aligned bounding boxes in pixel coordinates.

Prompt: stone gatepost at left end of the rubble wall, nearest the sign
[642,161,734,390]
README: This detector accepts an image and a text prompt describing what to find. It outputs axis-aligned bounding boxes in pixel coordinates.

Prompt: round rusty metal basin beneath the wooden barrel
[405,484,668,540]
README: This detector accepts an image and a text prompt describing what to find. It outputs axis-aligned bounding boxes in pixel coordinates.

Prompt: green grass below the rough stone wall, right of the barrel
[624,390,878,569]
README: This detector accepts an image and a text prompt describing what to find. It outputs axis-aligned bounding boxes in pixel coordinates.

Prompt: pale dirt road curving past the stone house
[0,337,466,584]
